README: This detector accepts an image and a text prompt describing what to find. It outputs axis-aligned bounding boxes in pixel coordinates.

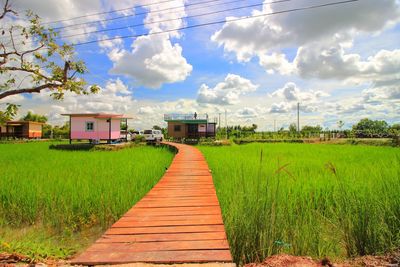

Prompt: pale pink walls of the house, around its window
[71,117,121,139]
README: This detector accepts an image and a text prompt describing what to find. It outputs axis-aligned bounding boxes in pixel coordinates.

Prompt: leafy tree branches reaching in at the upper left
[0,0,99,119]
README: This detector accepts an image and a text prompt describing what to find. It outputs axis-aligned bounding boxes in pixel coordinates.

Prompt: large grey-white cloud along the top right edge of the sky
[211,0,399,61]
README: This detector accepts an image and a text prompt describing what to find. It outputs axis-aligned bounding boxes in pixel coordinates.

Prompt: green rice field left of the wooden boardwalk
[0,142,173,258]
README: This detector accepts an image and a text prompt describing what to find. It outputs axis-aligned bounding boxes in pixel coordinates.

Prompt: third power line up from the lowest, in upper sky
[54,0,245,30]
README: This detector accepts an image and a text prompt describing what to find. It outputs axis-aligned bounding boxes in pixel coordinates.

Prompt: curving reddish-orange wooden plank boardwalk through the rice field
[71,143,232,265]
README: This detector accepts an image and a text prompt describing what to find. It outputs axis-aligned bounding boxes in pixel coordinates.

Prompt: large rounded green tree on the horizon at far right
[353,119,389,138]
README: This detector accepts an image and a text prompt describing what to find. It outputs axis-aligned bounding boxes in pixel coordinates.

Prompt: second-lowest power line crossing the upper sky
[56,0,286,39]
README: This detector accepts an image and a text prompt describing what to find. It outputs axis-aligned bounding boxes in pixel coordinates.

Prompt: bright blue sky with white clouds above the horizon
[3,0,400,130]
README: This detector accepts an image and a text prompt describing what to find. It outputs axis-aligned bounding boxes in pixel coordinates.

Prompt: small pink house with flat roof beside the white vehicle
[61,113,130,143]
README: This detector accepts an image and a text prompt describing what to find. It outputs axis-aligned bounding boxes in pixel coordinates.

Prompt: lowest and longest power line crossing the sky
[73,0,359,46]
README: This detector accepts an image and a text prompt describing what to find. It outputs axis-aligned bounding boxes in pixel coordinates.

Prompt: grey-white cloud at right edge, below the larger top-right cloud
[293,38,400,83]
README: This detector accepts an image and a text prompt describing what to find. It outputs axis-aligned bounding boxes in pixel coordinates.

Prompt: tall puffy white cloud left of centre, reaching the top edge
[100,0,193,89]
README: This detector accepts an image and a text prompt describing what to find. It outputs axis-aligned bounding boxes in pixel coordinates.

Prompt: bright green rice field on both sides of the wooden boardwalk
[0,142,400,264]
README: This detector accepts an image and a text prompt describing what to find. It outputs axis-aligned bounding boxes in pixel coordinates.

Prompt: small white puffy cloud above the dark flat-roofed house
[197,73,258,105]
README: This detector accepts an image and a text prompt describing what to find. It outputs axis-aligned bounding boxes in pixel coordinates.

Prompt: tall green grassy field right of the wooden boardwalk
[200,144,400,263]
